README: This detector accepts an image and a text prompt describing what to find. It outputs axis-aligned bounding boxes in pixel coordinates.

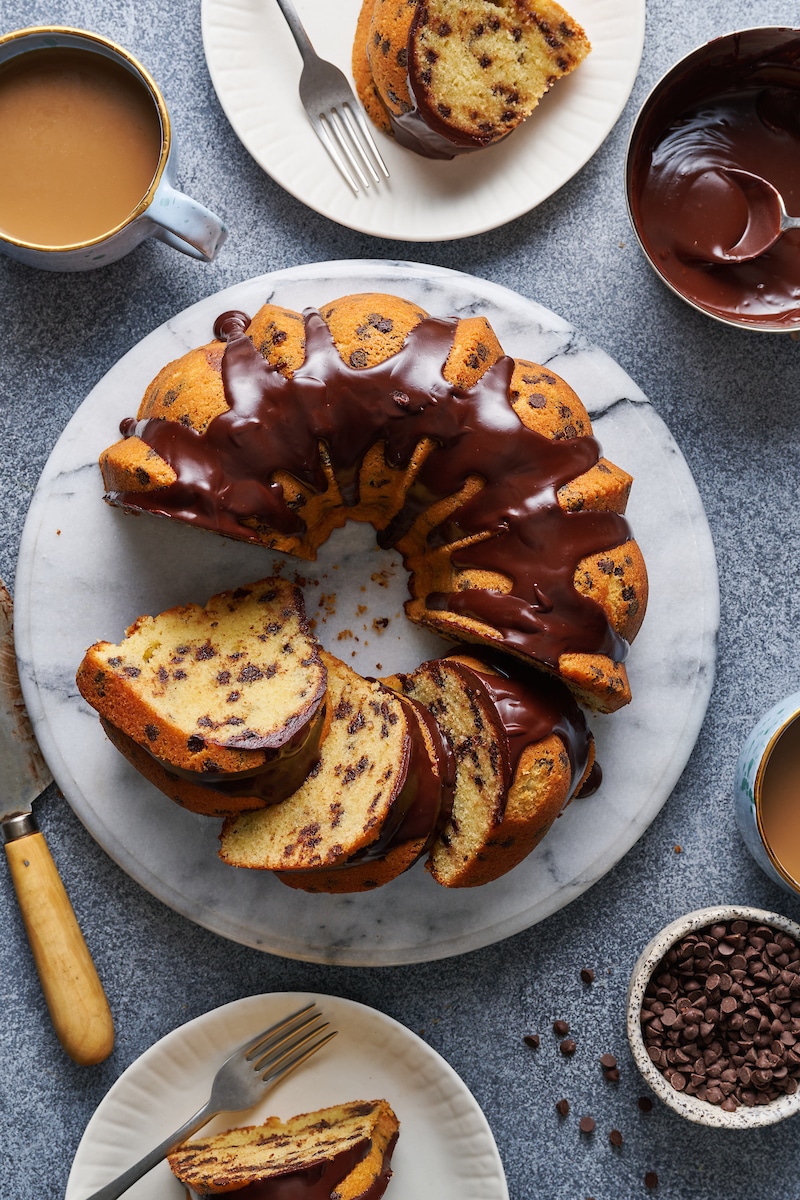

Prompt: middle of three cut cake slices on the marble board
[219,650,443,892]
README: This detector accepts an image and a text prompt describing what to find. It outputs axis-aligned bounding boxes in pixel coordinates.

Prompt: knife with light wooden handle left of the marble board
[0,580,114,1066]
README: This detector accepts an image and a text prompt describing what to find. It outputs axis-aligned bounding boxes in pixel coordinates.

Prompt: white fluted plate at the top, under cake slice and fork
[201,0,644,241]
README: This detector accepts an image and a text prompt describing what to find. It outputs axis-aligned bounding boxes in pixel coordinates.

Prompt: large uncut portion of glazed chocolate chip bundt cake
[101,294,646,710]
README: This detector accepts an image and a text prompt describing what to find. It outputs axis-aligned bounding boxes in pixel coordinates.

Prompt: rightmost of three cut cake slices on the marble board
[386,652,595,888]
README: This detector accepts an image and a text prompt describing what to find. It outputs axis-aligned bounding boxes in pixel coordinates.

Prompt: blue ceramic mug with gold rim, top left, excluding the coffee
[0,26,227,271]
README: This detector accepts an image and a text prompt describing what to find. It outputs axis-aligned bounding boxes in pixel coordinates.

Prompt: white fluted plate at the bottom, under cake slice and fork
[65,992,509,1200]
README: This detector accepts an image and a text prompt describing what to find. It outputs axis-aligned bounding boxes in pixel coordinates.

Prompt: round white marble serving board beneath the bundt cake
[16,262,718,965]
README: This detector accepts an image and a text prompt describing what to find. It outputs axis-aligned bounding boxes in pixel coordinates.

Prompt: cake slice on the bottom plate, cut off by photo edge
[168,1100,399,1200]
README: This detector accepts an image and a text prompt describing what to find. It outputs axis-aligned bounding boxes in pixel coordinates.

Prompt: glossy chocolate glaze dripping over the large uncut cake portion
[112,308,630,667]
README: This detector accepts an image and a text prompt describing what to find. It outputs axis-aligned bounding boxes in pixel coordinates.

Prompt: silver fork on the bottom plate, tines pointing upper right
[86,1003,337,1200]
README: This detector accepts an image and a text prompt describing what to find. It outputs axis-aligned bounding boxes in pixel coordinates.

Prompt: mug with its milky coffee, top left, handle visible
[0,26,227,271]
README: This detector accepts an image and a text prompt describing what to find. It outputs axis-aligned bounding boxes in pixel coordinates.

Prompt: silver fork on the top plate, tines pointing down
[277,0,389,193]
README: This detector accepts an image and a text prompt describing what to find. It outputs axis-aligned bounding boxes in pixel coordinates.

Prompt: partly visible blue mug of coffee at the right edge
[734,691,800,896]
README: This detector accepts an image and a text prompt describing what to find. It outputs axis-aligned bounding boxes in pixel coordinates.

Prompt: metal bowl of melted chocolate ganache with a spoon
[625,26,800,332]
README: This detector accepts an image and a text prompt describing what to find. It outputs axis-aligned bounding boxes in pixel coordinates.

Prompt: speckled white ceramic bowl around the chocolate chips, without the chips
[627,905,800,1129]
